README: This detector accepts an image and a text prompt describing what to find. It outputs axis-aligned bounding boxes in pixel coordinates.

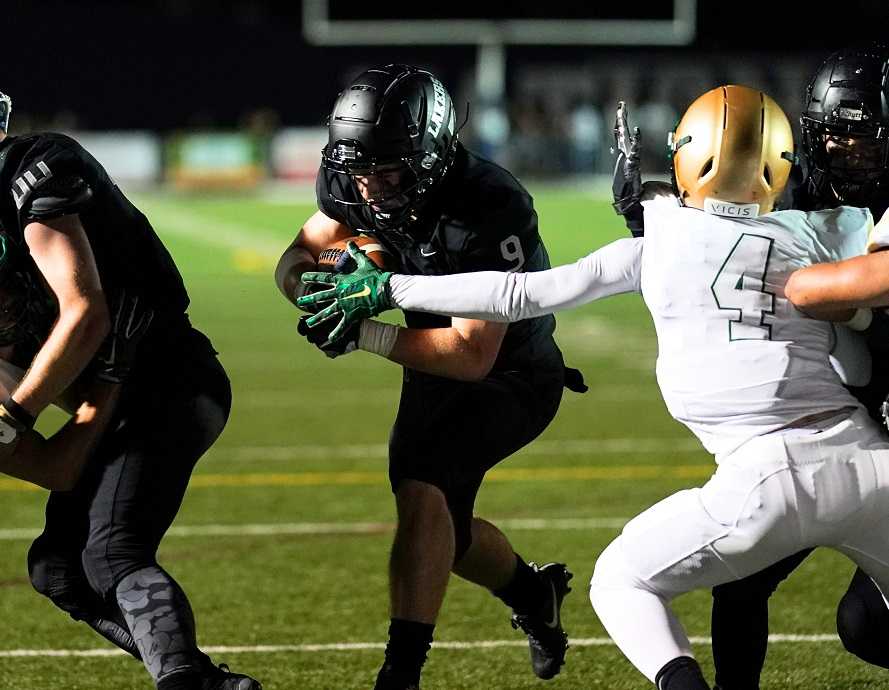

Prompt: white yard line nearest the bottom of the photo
[0,634,839,658]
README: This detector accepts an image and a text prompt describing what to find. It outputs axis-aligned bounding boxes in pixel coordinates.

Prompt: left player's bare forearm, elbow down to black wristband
[12,296,110,417]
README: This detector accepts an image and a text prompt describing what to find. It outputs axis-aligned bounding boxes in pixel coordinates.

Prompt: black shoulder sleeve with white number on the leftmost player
[12,136,96,227]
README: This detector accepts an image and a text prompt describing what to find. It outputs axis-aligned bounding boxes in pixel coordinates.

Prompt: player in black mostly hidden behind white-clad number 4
[613,46,889,690]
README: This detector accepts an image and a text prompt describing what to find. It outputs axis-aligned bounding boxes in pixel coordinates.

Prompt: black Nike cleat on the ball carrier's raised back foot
[512,563,574,680]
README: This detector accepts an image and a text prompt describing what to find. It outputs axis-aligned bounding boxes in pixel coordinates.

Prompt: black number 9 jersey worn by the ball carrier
[316,145,562,369]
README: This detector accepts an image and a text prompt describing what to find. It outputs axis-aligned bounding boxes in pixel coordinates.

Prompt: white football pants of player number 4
[590,410,889,682]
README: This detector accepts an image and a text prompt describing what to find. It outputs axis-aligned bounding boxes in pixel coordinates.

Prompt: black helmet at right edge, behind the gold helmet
[800,44,889,206]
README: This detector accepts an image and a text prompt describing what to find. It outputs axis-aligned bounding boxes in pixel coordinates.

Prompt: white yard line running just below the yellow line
[0,517,629,541]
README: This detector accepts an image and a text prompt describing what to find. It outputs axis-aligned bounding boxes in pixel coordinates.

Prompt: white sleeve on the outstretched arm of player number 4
[389,238,642,321]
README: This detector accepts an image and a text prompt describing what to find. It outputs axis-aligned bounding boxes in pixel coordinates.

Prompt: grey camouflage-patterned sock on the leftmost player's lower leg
[116,565,201,688]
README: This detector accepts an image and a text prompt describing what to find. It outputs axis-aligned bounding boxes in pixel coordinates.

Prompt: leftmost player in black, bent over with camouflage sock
[0,92,260,690]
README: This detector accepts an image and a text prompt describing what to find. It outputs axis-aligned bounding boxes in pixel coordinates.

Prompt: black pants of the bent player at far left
[28,331,231,620]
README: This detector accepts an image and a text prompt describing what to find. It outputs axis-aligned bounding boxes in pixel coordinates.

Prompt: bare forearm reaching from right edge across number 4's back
[784,251,889,310]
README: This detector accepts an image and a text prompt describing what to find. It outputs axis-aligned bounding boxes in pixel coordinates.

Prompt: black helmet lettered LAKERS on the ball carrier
[321,65,457,239]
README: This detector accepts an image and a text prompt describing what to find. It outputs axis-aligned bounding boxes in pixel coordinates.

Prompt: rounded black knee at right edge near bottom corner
[837,571,889,668]
